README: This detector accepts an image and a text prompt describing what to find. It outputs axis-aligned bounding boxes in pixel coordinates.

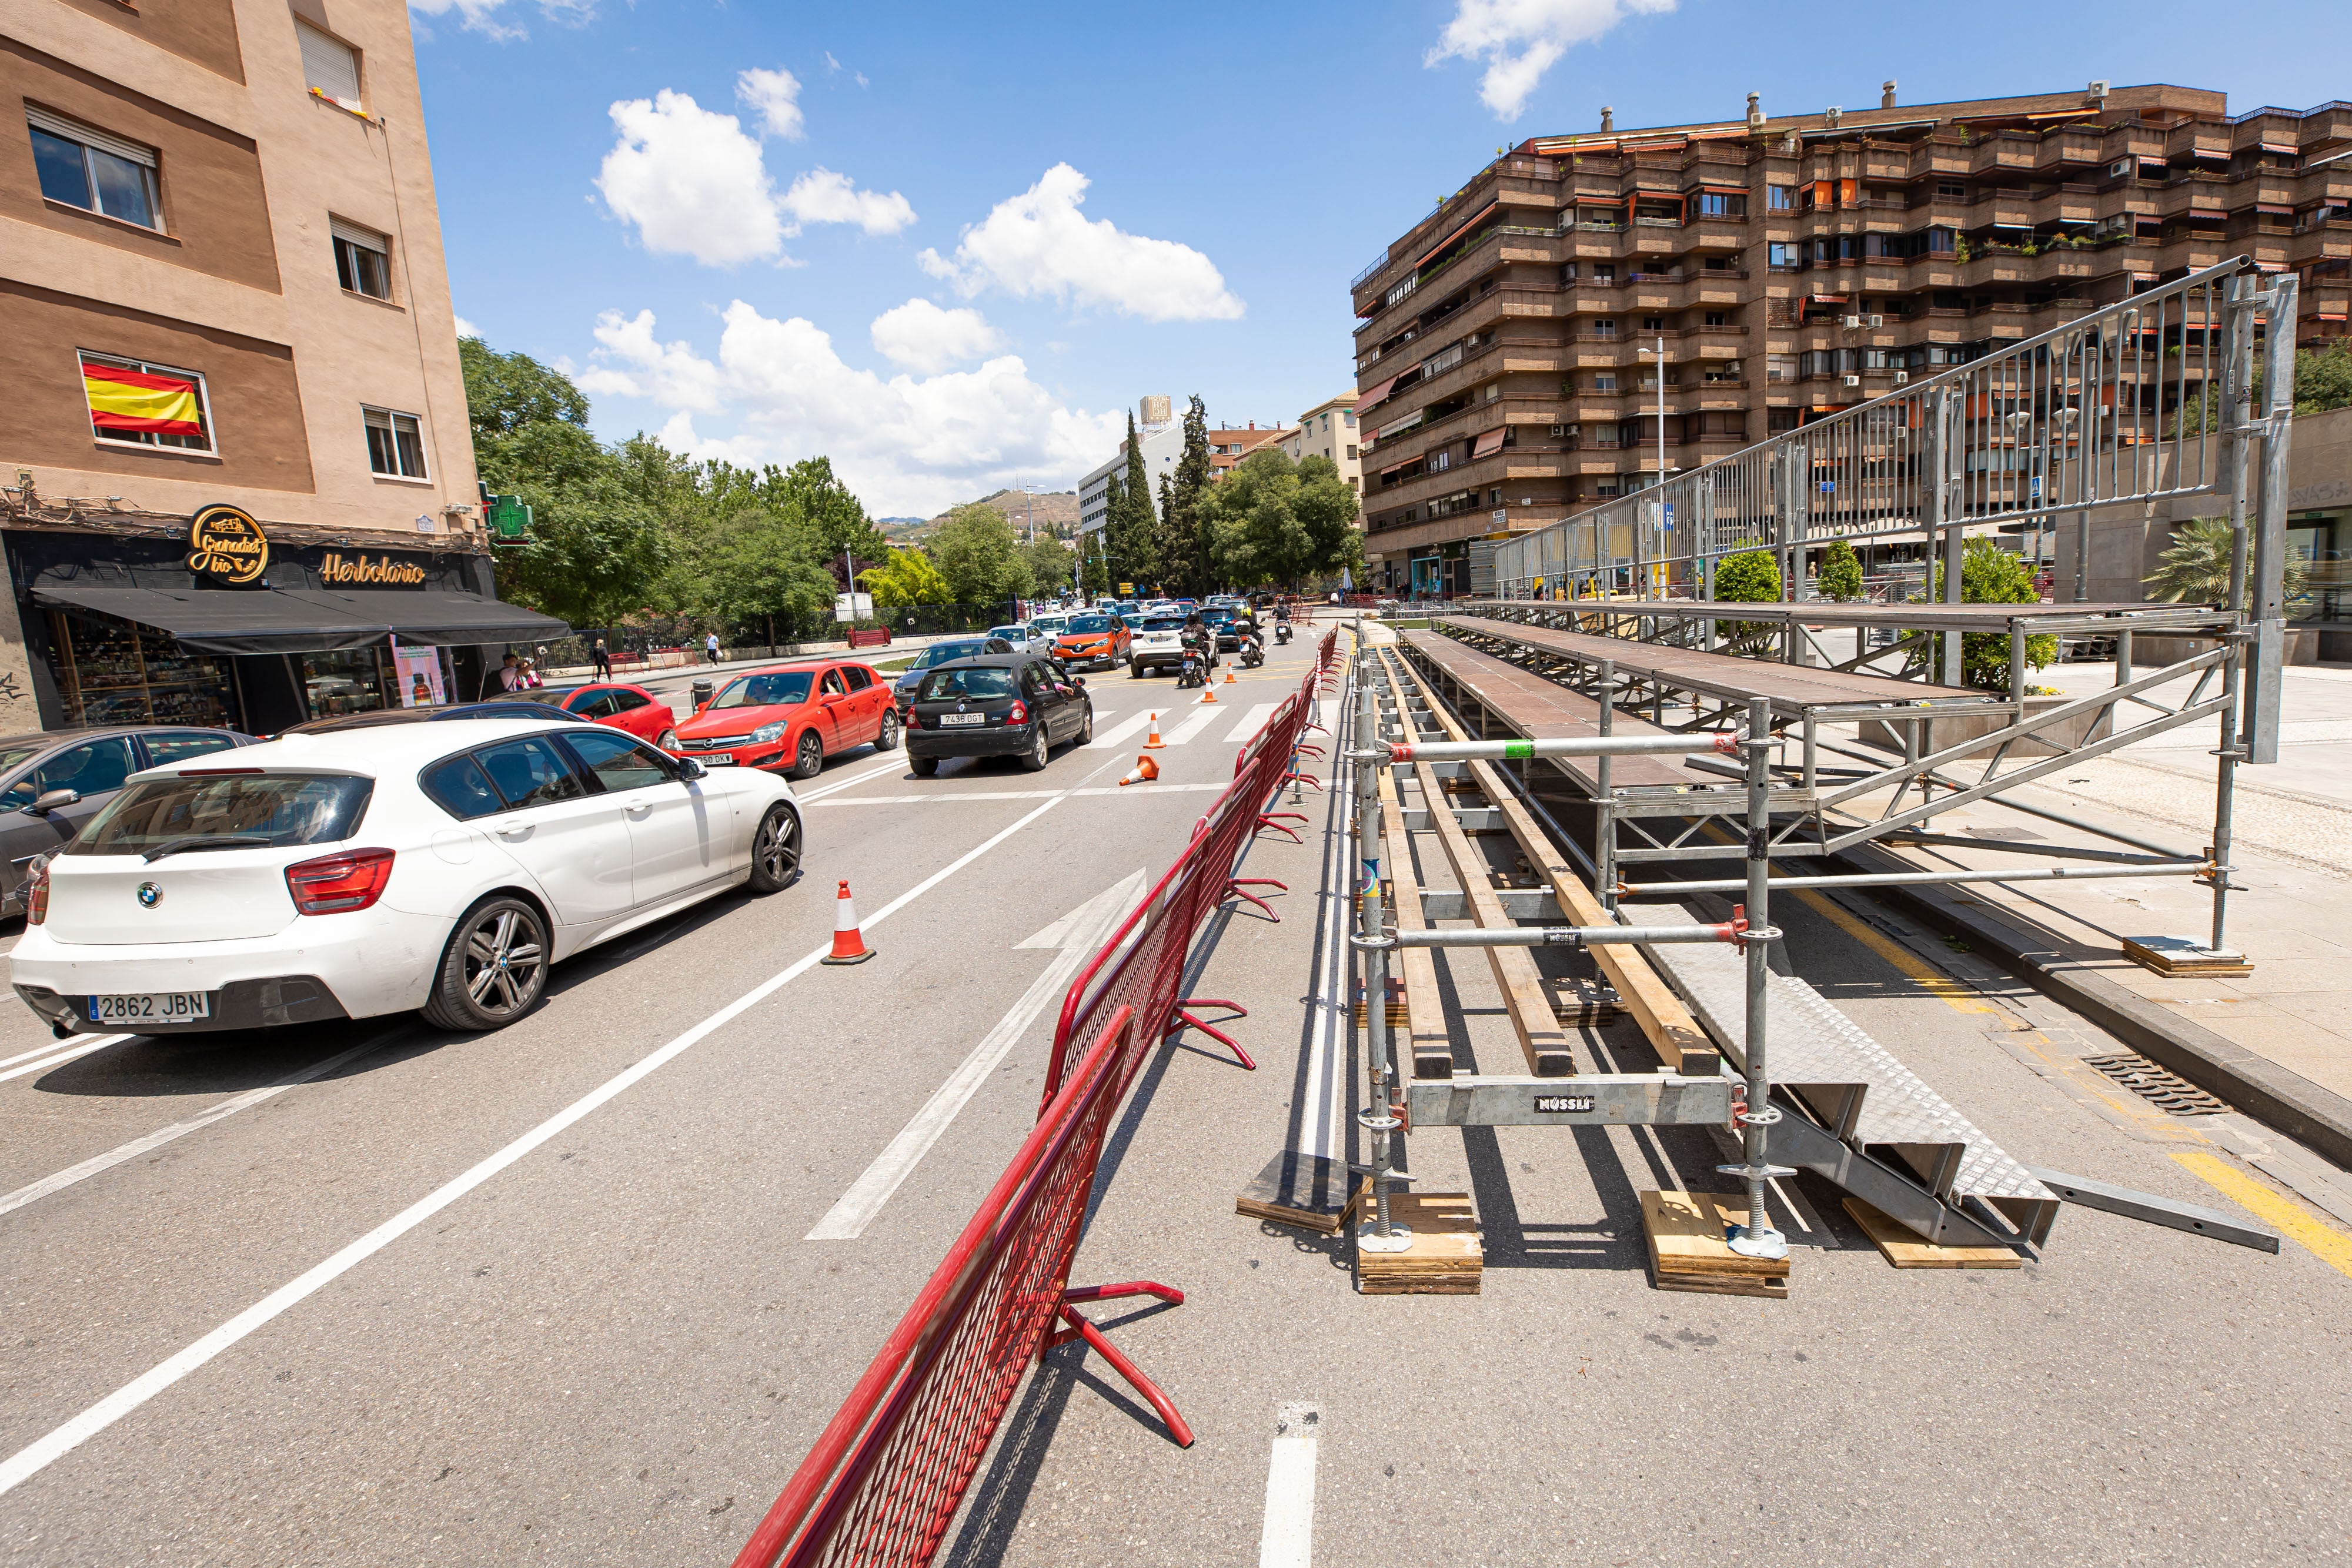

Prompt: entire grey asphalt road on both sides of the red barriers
[0,620,2352,1566]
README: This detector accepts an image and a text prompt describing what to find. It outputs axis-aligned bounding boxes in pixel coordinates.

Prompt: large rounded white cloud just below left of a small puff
[595,87,783,266]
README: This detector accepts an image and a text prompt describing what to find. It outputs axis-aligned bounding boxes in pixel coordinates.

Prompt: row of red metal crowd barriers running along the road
[736,633,1336,1568]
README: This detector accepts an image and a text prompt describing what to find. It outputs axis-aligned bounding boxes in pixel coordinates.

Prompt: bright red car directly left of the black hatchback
[673,661,898,778]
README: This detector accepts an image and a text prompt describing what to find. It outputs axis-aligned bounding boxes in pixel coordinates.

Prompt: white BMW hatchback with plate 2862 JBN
[9,720,802,1034]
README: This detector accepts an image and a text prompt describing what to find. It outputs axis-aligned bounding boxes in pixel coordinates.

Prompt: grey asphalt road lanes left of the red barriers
[0,644,1308,1563]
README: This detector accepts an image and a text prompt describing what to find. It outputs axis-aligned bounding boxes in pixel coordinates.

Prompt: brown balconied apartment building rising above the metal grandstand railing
[1352,82,2352,593]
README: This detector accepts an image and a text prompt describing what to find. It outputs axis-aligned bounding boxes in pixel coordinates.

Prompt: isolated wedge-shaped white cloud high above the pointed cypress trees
[917,162,1242,322]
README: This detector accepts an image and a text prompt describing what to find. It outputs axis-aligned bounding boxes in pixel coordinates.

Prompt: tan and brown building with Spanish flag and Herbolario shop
[0,0,562,731]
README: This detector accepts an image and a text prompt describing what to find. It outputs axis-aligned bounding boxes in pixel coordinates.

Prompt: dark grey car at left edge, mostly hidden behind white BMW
[0,724,254,914]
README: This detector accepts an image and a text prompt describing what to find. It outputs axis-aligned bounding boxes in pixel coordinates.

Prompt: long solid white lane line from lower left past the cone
[0,799,1061,1493]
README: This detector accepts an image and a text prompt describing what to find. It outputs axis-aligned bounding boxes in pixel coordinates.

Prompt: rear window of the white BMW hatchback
[66,771,376,855]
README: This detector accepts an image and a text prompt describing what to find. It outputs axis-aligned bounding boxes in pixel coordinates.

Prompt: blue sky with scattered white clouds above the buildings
[412,0,2352,515]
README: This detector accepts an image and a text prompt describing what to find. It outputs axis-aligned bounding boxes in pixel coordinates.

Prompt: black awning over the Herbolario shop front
[33,579,572,654]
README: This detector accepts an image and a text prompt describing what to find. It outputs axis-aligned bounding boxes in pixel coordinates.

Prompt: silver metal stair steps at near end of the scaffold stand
[1618,902,2058,1246]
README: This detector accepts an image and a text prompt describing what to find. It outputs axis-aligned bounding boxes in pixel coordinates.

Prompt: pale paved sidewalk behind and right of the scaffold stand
[1825,663,2352,1098]
